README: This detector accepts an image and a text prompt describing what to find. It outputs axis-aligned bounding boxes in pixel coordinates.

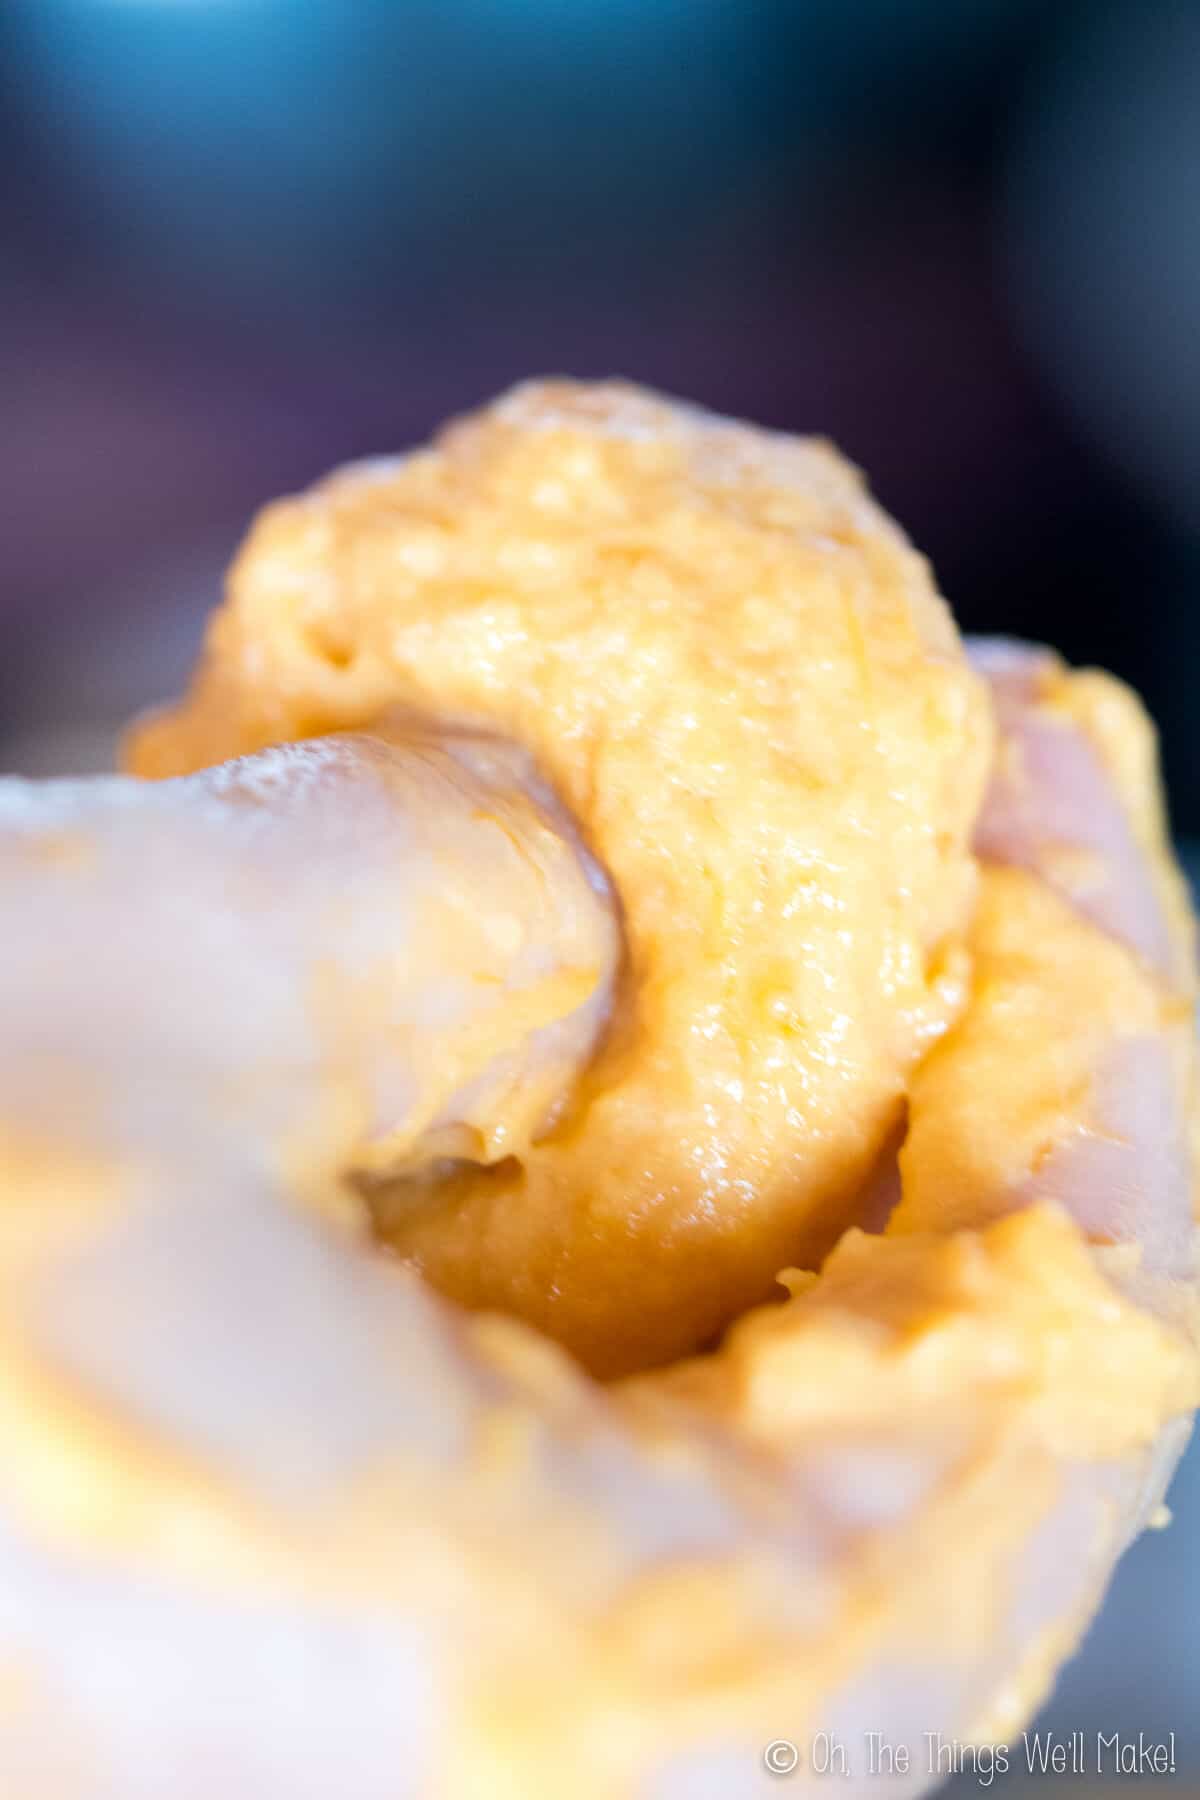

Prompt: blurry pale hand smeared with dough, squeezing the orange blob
[0,653,1200,1800]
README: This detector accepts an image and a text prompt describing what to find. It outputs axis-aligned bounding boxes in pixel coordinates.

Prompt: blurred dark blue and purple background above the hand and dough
[0,0,1200,832]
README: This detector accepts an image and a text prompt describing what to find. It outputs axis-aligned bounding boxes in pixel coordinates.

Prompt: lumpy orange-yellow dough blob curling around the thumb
[130,383,991,1375]
